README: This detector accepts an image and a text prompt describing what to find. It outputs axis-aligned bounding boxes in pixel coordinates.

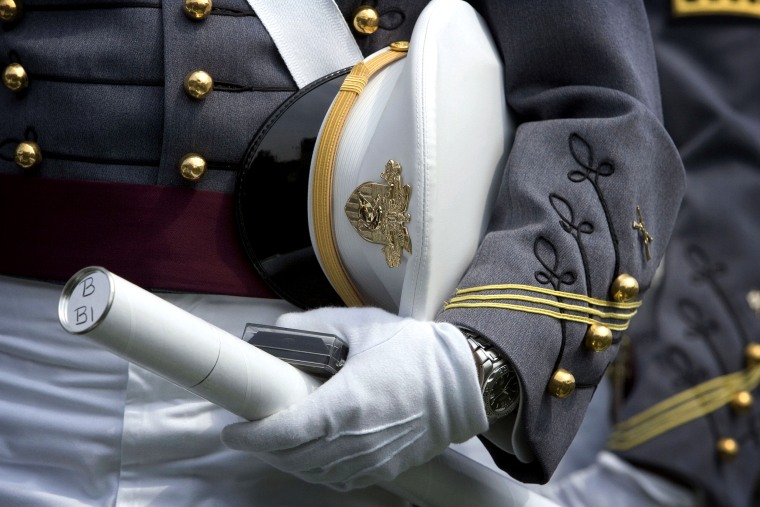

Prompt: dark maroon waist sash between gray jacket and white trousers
[0,175,276,298]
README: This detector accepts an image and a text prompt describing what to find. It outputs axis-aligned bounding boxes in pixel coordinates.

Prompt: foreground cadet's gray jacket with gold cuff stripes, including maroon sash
[0,0,683,488]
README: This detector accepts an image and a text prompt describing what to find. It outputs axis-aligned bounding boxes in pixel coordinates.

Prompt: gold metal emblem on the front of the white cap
[345,160,412,268]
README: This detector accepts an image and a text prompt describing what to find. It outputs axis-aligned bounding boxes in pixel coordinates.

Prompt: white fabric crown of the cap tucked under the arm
[309,0,512,319]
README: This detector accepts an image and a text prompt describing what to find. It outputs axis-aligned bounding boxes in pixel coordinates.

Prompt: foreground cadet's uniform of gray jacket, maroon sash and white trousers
[0,0,683,505]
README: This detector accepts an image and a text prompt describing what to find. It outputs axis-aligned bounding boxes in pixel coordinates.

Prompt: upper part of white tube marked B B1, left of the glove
[58,267,320,421]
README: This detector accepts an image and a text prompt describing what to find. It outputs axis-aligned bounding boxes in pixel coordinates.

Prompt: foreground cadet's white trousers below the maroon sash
[0,277,407,507]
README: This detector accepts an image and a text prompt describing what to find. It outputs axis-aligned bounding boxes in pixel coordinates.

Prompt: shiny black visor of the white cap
[235,69,350,309]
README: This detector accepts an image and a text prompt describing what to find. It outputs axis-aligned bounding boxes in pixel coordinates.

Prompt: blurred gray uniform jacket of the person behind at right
[611,0,760,506]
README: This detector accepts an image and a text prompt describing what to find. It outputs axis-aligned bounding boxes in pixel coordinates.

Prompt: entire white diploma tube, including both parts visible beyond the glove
[58,267,556,507]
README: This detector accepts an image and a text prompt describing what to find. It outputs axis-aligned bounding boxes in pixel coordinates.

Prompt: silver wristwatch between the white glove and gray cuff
[460,328,520,424]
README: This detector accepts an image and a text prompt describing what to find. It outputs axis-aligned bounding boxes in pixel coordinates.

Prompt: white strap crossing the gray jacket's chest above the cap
[243,0,363,88]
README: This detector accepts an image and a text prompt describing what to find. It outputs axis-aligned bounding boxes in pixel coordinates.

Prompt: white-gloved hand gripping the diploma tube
[222,308,488,490]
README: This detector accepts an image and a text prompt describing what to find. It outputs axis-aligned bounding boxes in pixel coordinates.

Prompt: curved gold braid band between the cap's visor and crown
[311,46,406,306]
